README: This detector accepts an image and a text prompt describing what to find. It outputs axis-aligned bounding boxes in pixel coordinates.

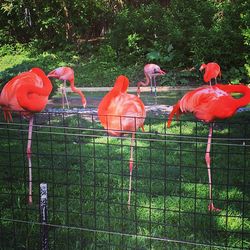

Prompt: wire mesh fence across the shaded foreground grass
[0,112,250,249]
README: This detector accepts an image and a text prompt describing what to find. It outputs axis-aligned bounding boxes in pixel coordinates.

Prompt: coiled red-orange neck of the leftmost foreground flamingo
[16,68,52,112]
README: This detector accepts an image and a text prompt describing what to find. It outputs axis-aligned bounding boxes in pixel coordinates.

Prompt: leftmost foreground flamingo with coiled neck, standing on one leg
[0,68,52,204]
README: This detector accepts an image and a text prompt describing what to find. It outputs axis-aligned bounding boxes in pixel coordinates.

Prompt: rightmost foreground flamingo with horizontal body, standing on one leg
[168,84,250,211]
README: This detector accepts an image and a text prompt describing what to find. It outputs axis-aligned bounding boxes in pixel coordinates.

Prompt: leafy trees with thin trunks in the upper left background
[0,0,120,49]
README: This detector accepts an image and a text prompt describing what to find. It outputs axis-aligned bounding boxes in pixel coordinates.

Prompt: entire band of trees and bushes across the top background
[0,0,250,82]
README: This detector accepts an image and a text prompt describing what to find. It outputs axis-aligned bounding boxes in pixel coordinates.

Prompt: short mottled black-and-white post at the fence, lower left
[40,183,49,250]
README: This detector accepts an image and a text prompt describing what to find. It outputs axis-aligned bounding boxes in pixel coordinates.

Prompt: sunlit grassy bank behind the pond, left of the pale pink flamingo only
[0,44,144,92]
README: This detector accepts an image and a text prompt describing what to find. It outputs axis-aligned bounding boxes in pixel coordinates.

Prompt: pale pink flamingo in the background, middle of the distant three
[137,63,166,97]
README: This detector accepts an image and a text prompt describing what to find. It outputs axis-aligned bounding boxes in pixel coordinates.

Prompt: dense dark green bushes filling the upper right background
[110,0,250,80]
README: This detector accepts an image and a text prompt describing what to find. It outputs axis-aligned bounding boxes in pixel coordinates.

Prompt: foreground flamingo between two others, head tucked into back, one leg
[98,75,146,208]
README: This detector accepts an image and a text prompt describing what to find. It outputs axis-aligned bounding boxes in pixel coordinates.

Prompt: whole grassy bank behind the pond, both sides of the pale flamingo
[0,44,201,94]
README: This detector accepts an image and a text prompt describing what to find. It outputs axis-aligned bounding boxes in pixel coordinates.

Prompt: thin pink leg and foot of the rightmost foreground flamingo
[205,124,220,211]
